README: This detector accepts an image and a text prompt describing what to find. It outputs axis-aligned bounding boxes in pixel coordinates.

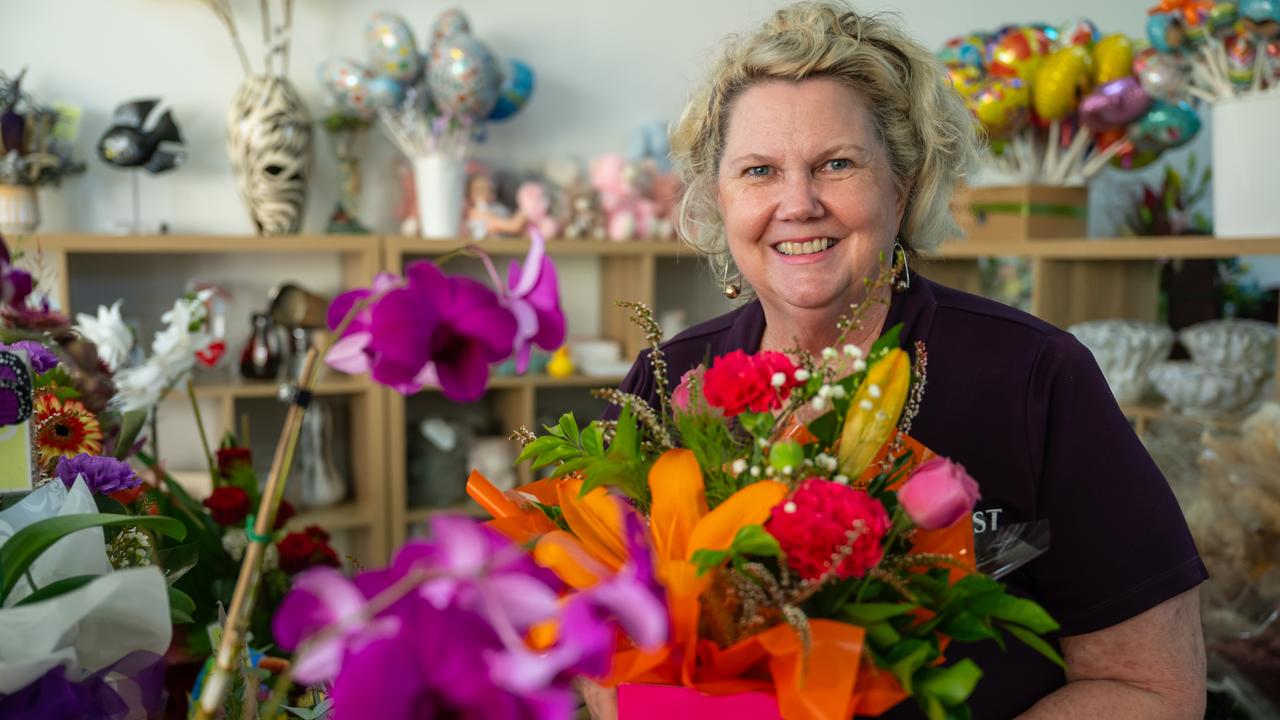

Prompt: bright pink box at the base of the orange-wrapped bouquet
[618,684,782,720]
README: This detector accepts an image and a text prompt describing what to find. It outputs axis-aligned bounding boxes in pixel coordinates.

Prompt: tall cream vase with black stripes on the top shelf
[227,76,311,234]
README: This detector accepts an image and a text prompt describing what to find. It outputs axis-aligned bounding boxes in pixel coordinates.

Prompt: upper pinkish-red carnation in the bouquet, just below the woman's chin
[703,350,799,418]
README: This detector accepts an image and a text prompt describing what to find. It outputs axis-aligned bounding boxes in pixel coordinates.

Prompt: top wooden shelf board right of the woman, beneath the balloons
[937,236,1280,260]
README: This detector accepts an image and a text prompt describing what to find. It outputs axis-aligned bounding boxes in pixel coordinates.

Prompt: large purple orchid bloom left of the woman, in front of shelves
[367,260,516,402]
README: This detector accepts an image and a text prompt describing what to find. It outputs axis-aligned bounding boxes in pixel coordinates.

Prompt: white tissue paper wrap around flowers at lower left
[0,479,173,694]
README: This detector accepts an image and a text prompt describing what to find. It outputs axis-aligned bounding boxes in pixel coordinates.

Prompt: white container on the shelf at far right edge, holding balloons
[1212,90,1280,237]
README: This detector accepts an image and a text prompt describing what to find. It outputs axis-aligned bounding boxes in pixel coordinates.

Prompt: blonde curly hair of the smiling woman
[671,0,977,281]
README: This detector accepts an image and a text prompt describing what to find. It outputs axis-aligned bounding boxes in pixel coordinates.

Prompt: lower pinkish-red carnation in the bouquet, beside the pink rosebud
[764,478,890,580]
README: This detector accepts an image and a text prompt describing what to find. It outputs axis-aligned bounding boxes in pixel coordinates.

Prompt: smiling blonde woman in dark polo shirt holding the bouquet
[606,1,1206,719]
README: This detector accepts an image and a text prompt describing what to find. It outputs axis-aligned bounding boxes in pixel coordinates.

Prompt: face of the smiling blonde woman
[718,78,905,310]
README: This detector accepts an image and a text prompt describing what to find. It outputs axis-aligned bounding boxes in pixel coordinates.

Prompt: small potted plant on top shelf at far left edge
[0,69,84,234]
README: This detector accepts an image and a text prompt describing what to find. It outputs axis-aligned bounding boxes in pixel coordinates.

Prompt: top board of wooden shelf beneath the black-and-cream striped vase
[23,233,378,255]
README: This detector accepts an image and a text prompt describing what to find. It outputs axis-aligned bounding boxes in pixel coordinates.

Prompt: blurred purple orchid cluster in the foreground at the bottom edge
[273,512,667,720]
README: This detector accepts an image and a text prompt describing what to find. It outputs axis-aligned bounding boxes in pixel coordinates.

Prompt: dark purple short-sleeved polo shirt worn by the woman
[622,275,1208,719]
